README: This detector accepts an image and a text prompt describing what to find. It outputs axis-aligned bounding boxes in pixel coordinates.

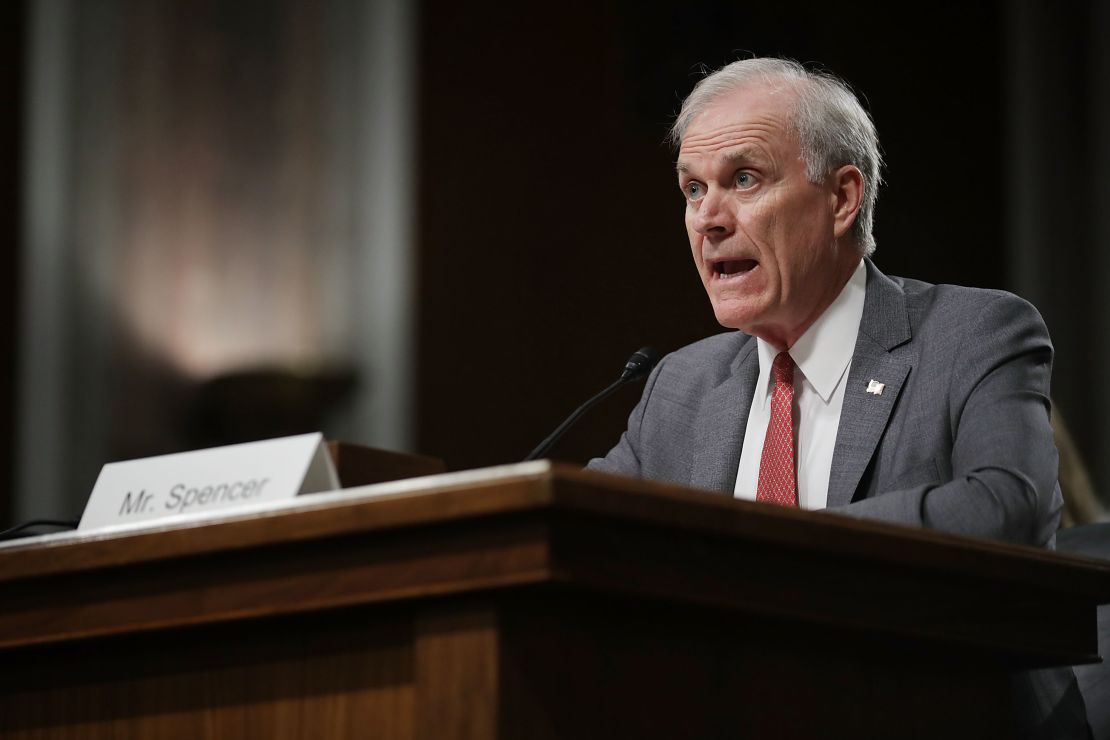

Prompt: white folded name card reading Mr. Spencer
[78,433,340,529]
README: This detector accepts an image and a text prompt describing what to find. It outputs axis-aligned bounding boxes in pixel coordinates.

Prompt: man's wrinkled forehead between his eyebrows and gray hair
[678,83,800,163]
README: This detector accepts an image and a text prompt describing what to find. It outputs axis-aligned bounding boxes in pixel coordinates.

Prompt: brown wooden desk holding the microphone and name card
[0,462,1110,740]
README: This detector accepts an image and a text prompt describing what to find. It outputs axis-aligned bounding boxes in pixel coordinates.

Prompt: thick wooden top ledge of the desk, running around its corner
[0,462,1110,666]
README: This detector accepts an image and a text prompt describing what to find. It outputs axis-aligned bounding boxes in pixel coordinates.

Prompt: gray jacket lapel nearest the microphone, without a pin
[690,339,759,494]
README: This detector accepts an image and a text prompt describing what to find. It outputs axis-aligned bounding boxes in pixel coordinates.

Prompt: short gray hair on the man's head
[670,58,882,256]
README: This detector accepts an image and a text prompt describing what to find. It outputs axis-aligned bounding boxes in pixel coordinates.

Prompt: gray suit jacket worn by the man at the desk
[589,260,1062,545]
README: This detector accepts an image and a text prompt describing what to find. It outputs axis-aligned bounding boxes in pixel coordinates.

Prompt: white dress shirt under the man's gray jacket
[735,260,867,509]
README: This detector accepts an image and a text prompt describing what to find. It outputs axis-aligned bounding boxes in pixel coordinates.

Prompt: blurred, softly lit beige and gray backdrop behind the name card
[17,0,415,518]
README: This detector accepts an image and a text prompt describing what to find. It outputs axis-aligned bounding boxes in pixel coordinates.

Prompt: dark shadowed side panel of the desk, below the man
[500,597,1016,740]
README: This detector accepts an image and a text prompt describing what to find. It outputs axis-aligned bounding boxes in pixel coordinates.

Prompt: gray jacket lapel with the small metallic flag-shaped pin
[827,260,911,508]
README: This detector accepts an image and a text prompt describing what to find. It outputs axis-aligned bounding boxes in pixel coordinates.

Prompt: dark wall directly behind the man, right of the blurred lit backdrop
[417,0,1007,467]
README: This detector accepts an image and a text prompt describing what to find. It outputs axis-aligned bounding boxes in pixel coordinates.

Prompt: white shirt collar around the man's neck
[757,260,867,403]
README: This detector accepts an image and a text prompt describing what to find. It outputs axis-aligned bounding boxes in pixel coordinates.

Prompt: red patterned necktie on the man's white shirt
[756,352,798,506]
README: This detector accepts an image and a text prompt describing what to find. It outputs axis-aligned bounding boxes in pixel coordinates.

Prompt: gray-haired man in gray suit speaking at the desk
[589,59,1087,738]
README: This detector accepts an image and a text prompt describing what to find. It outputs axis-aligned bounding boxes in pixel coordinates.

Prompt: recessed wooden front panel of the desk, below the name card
[0,614,415,740]
